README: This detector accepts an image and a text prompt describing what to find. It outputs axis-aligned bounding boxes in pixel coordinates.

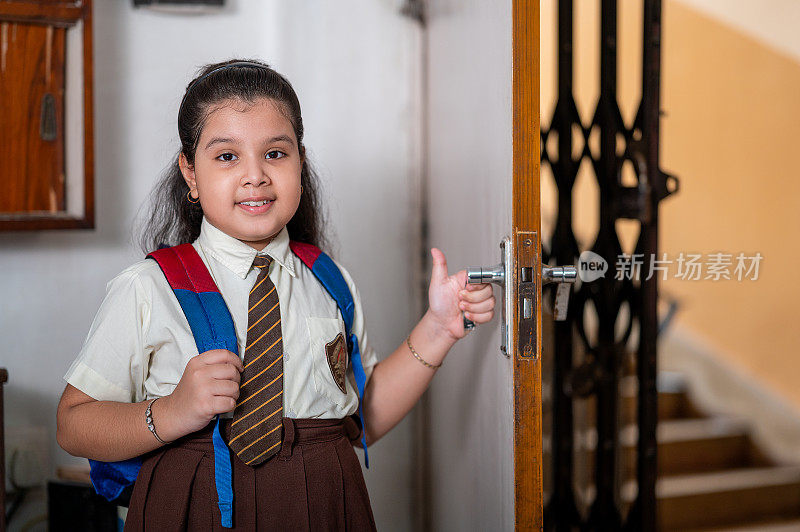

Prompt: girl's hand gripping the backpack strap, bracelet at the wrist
[159,349,244,441]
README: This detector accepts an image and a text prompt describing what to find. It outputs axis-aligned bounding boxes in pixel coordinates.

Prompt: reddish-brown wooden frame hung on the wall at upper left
[0,0,94,231]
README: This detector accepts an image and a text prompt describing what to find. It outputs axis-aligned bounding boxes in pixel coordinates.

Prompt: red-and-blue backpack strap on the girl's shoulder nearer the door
[289,240,369,469]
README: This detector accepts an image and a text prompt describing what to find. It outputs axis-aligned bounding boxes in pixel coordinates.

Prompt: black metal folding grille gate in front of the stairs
[541,0,678,531]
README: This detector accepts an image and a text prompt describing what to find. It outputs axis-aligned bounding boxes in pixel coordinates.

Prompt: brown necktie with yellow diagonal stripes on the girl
[228,255,283,466]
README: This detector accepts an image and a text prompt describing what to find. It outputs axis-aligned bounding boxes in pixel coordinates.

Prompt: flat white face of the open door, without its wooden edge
[426,0,514,531]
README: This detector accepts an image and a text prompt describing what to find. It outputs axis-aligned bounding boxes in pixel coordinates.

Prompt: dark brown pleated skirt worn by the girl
[125,417,375,532]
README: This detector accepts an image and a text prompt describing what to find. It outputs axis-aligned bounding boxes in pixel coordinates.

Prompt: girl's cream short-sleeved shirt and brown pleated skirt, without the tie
[65,215,378,530]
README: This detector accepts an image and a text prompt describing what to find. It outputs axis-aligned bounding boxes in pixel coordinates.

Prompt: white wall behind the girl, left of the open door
[0,0,419,530]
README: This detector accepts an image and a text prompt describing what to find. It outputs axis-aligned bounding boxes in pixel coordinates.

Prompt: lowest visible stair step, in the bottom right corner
[656,466,800,530]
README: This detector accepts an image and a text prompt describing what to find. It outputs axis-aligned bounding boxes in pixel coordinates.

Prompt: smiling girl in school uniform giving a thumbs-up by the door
[57,60,495,530]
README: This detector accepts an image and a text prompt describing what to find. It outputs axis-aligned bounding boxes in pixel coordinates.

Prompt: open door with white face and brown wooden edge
[424,0,542,530]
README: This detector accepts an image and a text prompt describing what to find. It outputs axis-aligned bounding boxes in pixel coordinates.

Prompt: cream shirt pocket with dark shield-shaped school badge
[306,316,349,408]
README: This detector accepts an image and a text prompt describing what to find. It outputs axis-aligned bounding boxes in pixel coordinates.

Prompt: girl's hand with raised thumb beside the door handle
[428,248,495,340]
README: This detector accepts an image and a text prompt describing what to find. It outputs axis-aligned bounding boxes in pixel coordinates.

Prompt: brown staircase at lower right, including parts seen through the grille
[542,362,800,532]
